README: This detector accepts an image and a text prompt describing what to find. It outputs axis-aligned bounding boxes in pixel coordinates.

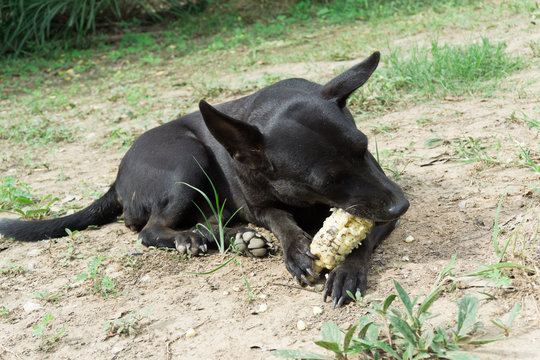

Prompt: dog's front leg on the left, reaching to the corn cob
[256,208,318,284]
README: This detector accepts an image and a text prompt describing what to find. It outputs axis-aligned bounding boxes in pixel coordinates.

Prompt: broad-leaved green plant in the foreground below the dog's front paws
[273,281,516,360]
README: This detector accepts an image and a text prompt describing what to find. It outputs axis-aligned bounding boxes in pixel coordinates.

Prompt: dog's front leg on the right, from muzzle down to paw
[323,220,397,308]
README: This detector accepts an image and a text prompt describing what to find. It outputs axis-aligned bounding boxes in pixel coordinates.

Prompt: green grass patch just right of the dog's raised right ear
[349,38,524,114]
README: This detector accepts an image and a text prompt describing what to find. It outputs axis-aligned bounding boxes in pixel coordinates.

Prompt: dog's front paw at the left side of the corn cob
[283,233,319,285]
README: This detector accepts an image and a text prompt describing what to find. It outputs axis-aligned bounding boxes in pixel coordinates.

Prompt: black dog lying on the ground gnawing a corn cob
[0,52,409,306]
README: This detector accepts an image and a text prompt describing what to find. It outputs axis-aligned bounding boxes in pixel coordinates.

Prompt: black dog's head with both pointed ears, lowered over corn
[200,52,409,221]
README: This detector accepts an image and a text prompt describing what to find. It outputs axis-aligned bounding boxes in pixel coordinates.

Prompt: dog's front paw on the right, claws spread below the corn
[323,262,367,308]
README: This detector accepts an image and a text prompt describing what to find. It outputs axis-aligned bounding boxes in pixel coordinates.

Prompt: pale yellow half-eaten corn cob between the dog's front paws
[310,209,374,273]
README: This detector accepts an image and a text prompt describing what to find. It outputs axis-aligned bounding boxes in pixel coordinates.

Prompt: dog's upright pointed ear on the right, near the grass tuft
[320,51,381,107]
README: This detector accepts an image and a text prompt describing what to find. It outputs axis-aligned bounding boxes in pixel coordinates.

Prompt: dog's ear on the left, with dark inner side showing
[199,100,269,169]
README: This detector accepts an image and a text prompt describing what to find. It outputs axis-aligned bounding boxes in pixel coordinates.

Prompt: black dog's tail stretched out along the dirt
[0,184,122,241]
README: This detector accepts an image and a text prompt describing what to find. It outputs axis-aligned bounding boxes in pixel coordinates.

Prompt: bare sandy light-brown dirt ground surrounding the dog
[0,5,540,359]
